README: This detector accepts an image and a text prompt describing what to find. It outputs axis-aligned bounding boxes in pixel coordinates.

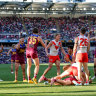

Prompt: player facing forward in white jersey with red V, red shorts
[38,34,66,82]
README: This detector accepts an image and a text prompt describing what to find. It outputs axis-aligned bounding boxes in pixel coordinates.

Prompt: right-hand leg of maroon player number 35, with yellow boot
[33,58,39,84]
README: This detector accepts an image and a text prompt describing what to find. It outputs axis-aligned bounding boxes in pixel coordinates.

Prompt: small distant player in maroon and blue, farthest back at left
[7,44,16,74]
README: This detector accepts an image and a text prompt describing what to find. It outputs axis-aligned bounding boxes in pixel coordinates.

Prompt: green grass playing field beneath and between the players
[0,63,96,96]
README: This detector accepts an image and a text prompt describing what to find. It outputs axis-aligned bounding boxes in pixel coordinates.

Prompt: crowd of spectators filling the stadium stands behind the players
[0,16,96,63]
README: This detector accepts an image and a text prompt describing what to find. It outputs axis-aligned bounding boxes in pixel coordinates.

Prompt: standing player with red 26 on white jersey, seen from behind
[73,28,90,84]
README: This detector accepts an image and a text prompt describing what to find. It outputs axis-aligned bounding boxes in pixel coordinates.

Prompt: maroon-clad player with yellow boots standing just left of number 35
[14,38,27,83]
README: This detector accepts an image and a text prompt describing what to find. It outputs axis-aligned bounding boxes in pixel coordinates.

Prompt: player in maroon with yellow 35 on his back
[26,28,46,84]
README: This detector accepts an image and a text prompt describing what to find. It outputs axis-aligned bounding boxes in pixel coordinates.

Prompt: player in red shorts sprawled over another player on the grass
[51,63,86,85]
